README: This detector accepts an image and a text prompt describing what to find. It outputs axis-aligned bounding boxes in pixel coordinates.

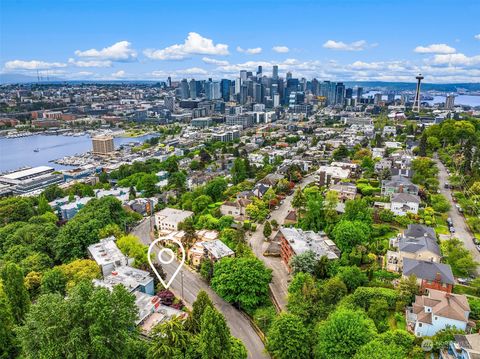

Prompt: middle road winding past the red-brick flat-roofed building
[250,176,314,311]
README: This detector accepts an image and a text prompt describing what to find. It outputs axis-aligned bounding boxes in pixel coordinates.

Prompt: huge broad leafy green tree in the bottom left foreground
[17,282,138,359]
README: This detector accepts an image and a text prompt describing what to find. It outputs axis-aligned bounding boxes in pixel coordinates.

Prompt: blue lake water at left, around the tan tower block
[0,135,154,172]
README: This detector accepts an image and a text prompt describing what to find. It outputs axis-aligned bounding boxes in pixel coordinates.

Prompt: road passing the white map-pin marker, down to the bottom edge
[132,219,269,359]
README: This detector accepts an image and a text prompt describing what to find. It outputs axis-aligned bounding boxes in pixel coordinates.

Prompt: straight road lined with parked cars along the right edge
[435,159,480,272]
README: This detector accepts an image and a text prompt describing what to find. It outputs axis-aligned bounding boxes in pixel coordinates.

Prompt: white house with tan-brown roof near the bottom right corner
[406,289,470,337]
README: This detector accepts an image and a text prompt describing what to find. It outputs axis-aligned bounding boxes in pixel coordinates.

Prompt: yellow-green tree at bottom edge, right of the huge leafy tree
[147,317,191,359]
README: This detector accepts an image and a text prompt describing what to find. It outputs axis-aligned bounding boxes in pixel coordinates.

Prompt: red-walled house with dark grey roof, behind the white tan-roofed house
[403,258,455,293]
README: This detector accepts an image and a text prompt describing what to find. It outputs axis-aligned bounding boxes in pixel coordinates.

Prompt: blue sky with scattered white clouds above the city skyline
[0,0,480,83]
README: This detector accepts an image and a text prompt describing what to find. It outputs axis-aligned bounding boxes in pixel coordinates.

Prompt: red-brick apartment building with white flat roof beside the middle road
[277,227,340,271]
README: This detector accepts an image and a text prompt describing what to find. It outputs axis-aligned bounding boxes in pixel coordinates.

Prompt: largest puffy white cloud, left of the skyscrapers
[143,32,229,60]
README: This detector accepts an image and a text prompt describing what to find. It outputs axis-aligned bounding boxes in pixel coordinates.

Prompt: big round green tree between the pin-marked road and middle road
[211,257,272,310]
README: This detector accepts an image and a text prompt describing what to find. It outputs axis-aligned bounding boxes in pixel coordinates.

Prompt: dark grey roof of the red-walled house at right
[403,258,455,284]
